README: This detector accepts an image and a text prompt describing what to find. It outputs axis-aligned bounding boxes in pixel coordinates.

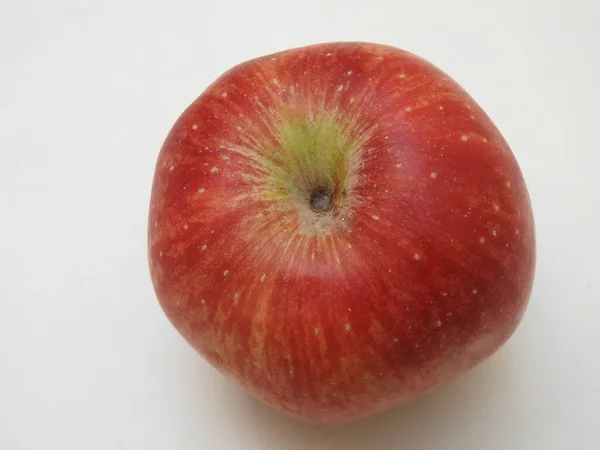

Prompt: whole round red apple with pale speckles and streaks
[148,42,535,423]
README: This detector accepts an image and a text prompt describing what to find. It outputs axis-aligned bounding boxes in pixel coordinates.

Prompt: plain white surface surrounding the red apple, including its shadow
[0,0,600,450]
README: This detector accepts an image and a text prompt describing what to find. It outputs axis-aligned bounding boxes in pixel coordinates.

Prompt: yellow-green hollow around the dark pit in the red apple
[260,114,362,236]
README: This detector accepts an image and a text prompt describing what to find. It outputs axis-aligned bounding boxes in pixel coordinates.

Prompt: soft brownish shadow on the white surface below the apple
[195,341,524,450]
